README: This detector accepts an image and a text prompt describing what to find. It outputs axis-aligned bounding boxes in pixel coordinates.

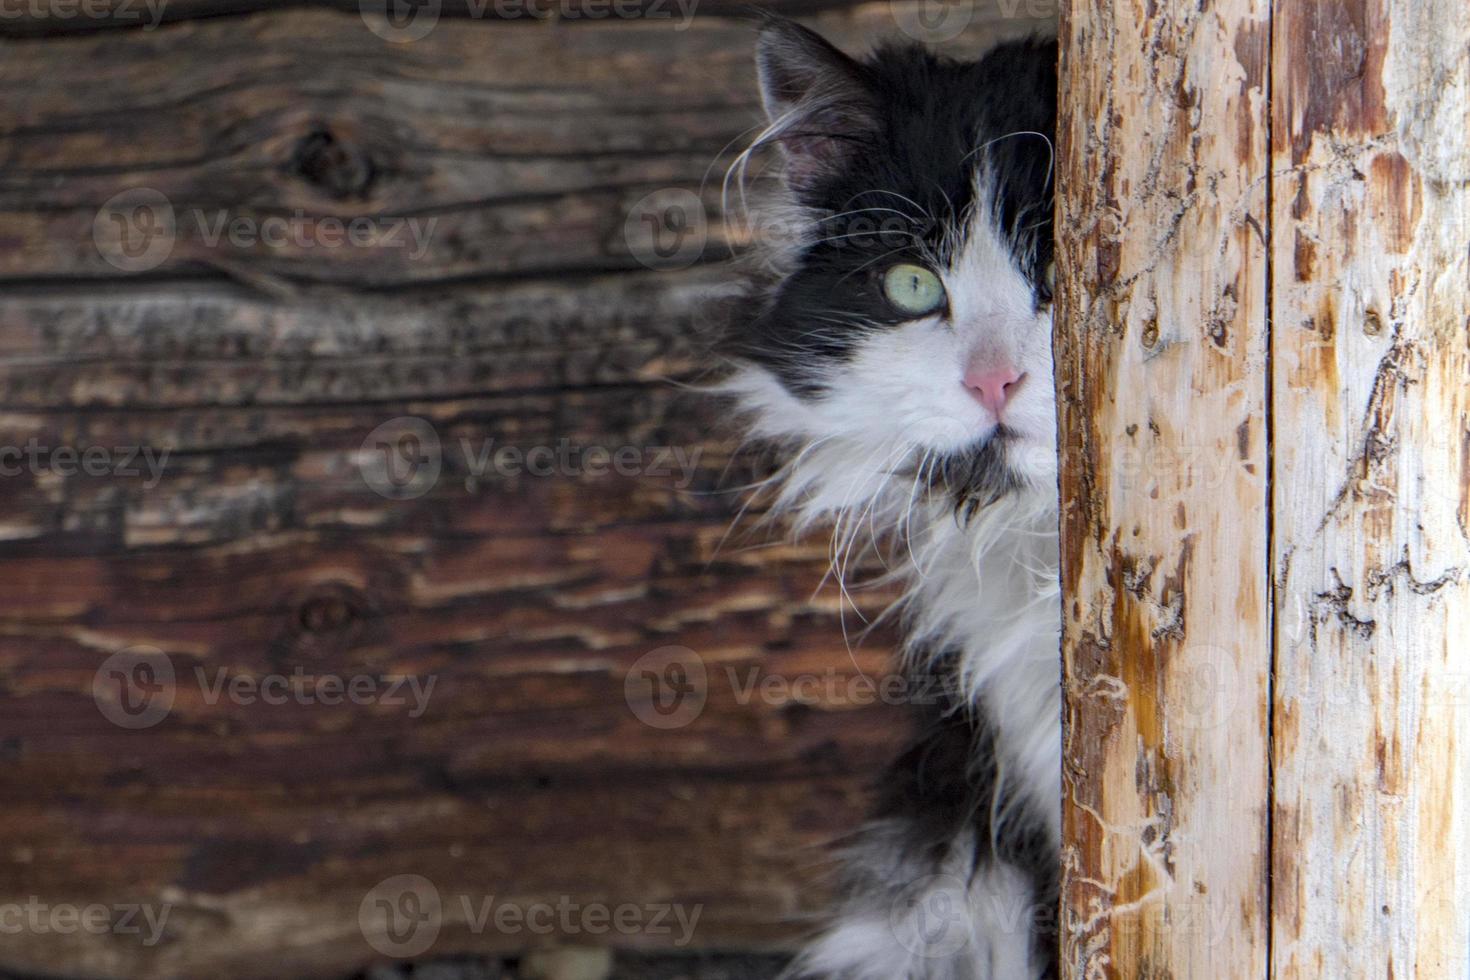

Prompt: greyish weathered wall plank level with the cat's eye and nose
[0,274,729,411]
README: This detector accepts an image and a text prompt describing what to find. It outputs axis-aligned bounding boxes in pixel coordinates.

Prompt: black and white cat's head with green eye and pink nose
[735,21,1055,514]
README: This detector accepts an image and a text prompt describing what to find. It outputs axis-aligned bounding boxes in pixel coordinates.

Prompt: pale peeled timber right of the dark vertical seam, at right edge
[1272,0,1470,980]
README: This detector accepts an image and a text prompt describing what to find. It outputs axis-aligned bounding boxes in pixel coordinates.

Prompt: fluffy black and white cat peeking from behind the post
[723,19,1060,980]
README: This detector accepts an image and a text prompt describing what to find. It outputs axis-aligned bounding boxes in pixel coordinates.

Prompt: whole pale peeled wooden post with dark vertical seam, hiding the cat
[1057,0,1470,980]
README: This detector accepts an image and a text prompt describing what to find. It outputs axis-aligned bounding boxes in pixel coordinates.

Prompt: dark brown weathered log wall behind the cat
[0,3,1070,979]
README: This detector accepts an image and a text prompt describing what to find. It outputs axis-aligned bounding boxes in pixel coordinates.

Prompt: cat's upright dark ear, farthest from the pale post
[756,18,878,192]
